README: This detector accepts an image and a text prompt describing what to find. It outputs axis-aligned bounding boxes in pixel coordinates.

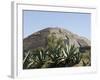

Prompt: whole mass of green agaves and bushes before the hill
[23,36,90,69]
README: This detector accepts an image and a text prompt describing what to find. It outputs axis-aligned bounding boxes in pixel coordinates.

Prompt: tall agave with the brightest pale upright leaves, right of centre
[64,45,81,66]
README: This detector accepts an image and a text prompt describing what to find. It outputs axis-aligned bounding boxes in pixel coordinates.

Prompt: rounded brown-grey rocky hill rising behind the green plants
[23,28,91,51]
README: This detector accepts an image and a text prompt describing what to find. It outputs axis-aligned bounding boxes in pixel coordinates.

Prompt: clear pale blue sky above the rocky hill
[23,10,91,39]
